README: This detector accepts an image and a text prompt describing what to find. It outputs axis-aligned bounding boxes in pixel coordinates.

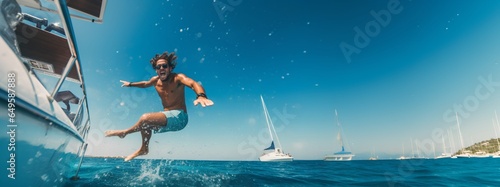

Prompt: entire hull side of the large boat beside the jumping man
[0,8,84,186]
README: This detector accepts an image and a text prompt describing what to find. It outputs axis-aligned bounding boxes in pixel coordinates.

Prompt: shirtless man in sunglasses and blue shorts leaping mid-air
[105,52,214,161]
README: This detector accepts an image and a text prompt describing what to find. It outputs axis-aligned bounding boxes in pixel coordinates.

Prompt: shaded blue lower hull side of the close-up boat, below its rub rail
[0,100,83,186]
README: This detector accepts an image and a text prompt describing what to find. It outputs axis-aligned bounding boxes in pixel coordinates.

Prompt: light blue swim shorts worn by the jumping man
[153,110,188,134]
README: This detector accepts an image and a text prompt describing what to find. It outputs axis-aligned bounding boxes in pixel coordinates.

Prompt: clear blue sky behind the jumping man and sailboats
[64,0,500,160]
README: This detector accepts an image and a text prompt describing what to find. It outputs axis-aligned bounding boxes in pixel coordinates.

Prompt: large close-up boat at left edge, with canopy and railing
[0,0,106,186]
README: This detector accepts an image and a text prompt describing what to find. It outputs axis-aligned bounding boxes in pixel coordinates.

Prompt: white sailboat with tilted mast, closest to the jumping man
[259,95,293,162]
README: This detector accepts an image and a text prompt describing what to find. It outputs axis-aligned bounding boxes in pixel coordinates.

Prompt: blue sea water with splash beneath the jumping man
[67,158,500,186]
